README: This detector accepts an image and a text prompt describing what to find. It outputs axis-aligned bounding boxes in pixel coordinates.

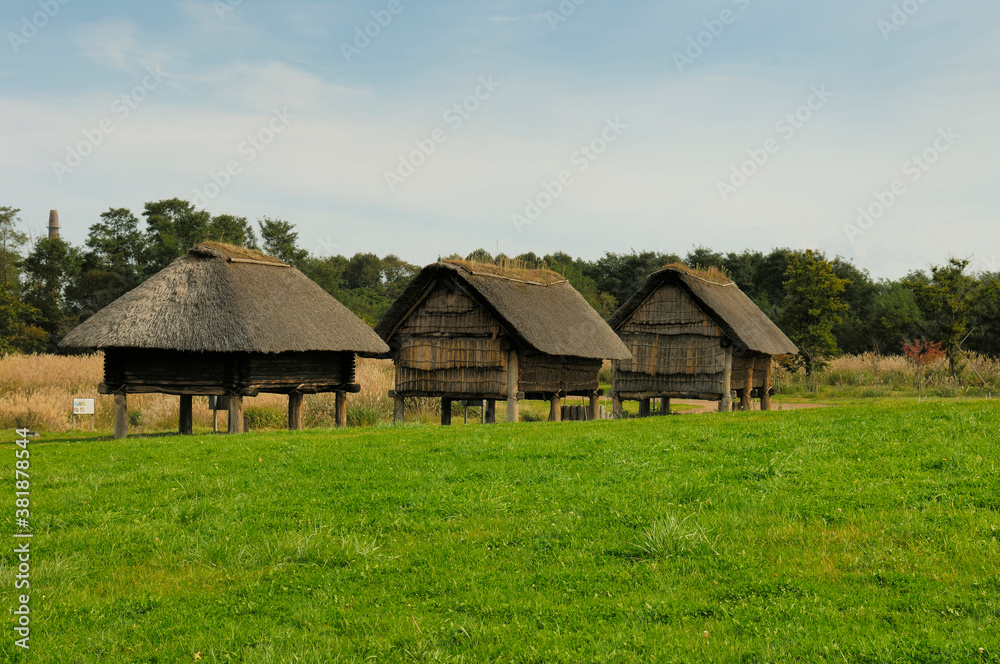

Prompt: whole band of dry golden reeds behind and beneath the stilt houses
[0,353,1000,433]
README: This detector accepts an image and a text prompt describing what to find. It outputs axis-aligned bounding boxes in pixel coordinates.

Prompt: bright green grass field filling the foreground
[0,401,1000,664]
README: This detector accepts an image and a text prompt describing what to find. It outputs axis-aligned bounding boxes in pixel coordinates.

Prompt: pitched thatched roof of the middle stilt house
[375,263,631,360]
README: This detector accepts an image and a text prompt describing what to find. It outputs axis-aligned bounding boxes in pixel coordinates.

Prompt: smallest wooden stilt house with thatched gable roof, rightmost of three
[608,265,798,416]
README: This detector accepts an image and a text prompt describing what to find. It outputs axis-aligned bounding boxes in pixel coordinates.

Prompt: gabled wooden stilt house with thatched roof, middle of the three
[375,261,629,424]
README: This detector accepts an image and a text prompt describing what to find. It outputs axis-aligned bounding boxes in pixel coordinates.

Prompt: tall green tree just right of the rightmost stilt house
[779,249,850,375]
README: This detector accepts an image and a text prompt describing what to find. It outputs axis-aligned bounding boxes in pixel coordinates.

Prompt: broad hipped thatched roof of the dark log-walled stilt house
[61,242,388,353]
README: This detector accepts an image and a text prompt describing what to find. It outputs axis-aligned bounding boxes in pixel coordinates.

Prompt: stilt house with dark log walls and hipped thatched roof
[61,242,388,438]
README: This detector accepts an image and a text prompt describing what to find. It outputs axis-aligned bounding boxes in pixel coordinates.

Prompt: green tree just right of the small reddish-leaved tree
[904,258,980,380]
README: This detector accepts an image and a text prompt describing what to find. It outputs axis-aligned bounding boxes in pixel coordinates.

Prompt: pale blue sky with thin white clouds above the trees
[0,0,1000,278]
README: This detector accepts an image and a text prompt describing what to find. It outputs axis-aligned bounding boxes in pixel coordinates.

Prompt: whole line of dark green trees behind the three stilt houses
[0,198,1000,374]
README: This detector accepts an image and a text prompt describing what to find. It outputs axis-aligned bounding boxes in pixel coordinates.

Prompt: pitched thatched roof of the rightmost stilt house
[608,265,799,355]
